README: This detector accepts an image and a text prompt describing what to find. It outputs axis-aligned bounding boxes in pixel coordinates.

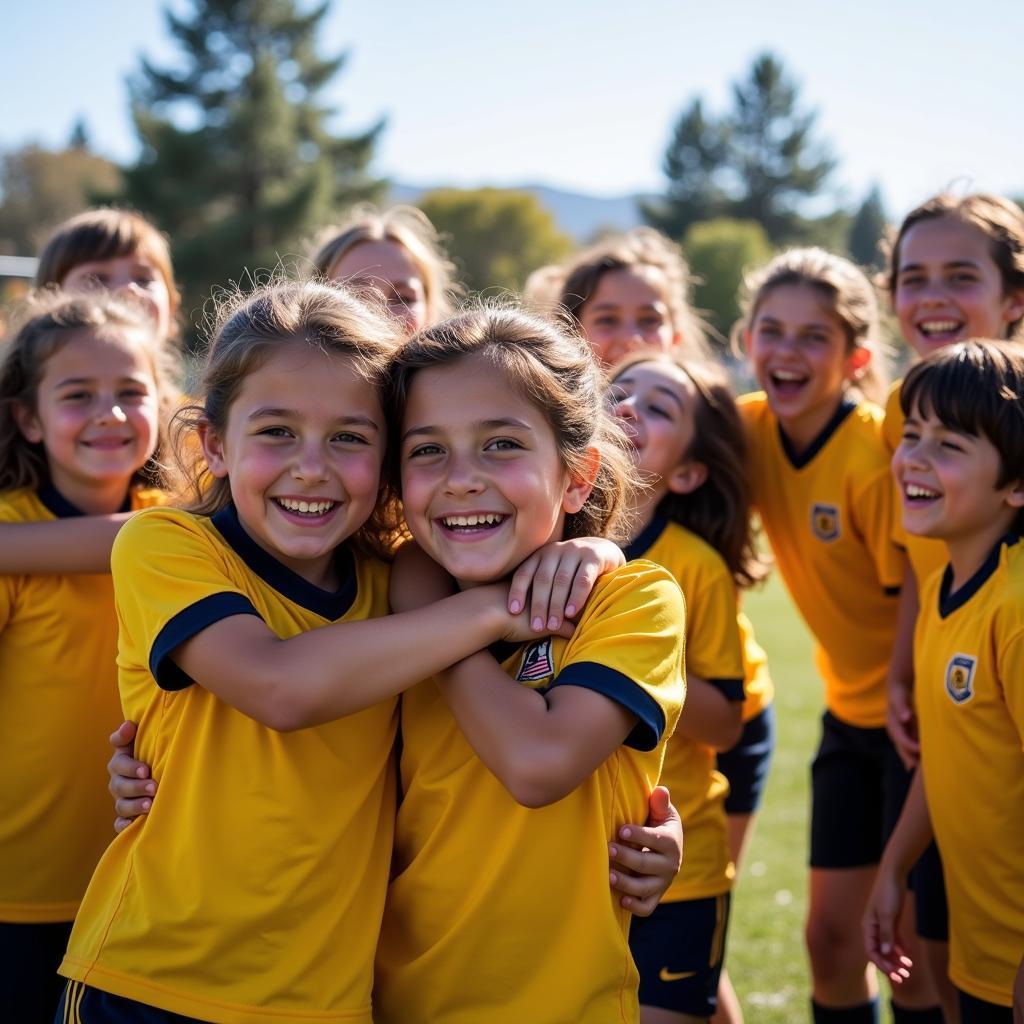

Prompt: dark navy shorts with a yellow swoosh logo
[630,893,729,1017]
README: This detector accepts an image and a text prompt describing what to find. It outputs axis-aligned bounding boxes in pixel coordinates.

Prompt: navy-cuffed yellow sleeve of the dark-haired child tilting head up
[684,563,743,700]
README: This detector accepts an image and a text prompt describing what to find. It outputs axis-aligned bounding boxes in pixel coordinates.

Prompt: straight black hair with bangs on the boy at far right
[899,339,1024,532]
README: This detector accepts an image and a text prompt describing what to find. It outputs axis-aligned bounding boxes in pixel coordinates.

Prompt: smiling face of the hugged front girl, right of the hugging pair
[401,355,590,586]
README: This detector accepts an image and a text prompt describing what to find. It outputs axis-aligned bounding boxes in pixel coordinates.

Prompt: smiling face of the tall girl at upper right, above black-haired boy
[894,217,1024,356]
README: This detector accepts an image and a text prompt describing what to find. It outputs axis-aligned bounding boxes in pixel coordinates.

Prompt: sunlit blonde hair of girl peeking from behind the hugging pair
[312,204,462,324]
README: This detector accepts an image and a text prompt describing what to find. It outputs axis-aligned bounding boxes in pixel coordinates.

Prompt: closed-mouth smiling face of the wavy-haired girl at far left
[17,329,158,512]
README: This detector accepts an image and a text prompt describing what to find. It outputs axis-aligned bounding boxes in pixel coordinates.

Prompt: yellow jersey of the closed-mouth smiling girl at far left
[0,486,163,923]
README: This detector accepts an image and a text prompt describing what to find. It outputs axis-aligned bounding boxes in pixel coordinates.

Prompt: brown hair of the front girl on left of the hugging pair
[174,281,402,556]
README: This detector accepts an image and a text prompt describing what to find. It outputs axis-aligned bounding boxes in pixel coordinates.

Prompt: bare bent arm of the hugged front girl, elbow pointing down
[430,652,636,807]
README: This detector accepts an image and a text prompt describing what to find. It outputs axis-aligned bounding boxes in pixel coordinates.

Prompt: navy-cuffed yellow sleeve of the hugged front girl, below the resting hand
[551,562,686,751]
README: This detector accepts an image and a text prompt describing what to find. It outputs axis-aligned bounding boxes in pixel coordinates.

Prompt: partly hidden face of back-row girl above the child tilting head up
[580,266,679,367]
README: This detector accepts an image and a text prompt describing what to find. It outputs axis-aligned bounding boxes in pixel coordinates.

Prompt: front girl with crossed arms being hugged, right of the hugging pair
[375,308,683,1024]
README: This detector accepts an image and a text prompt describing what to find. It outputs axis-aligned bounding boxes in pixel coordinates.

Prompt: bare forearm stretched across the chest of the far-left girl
[0,512,132,575]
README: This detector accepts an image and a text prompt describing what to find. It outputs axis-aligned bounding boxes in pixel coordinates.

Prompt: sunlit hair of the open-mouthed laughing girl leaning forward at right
[732,247,889,404]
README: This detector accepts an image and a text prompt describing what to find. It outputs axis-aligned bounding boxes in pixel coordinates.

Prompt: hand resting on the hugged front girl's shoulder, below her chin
[509,537,626,633]
